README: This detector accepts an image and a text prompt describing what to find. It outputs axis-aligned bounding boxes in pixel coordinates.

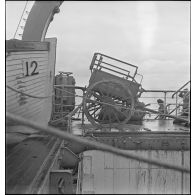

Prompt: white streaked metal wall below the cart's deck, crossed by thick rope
[79,150,190,194]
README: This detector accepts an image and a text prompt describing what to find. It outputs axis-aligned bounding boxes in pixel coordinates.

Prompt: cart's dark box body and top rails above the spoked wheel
[89,53,142,98]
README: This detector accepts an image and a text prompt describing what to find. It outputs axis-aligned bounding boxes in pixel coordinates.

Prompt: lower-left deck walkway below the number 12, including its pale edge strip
[6,126,61,194]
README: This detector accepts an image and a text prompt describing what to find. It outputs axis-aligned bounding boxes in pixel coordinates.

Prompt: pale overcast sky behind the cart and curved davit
[6,1,190,89]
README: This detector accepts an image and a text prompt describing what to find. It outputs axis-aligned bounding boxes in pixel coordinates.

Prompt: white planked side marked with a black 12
[6,38,57,124]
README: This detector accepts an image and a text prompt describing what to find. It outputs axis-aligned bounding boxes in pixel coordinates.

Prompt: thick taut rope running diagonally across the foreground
[6,112,190,173]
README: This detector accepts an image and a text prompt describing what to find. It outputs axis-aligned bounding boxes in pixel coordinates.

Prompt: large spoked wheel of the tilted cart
[83,80,134,127]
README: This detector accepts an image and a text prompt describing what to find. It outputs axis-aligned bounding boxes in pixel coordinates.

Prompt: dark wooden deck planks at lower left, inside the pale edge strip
[6,135,56,193]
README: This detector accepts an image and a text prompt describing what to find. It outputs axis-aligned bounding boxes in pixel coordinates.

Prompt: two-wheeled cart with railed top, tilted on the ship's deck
[83,53,144,125]
